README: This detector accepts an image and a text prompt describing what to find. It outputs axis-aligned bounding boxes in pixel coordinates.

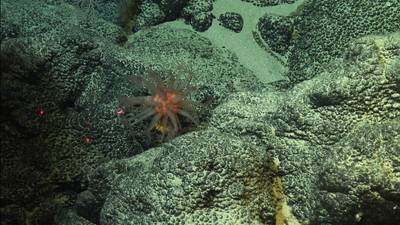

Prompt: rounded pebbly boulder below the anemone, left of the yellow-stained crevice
[84,129,273,225]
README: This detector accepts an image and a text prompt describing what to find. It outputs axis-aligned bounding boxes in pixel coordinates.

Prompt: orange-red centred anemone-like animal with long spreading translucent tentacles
[120,71,197,139]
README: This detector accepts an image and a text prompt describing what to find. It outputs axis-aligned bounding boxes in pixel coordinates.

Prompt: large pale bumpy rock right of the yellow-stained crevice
[211,33,400,225]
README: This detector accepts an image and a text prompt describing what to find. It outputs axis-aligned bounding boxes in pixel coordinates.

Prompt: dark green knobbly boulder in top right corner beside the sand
[288,0,400,82]
